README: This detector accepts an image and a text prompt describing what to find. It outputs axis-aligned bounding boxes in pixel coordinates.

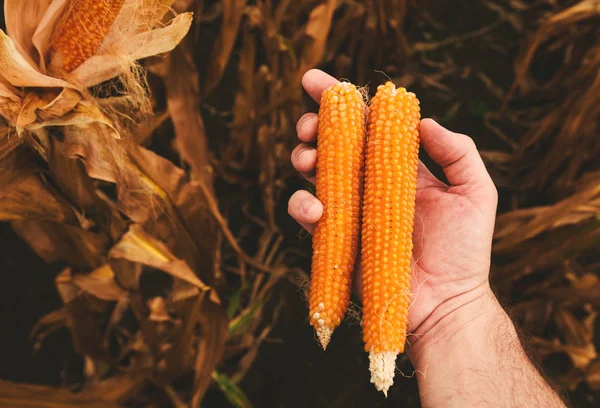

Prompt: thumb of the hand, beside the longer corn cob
[420,119,497,198]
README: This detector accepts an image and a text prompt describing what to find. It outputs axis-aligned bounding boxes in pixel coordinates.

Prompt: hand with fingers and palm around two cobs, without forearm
[288,70,497,363]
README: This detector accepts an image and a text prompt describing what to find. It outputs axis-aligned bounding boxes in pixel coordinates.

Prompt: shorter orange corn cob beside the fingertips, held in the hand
[309,82,366,349]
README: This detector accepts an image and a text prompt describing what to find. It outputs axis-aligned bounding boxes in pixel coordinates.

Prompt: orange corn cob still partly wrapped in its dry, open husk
[50,0,125,73]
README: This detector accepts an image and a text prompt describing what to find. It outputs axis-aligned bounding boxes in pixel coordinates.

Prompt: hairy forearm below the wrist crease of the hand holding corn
[408,286,564,407]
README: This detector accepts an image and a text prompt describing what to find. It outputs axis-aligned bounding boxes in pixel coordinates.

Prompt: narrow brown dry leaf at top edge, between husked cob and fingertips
[203,0,246,96]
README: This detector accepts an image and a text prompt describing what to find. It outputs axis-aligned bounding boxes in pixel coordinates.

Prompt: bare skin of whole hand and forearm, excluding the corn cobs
[288,70,565,407]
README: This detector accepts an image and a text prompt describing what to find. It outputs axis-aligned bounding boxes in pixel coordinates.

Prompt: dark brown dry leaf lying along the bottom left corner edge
[0,380,121,408]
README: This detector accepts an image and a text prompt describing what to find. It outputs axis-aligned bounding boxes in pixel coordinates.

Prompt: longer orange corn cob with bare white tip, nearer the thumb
[361,82,421,396]
